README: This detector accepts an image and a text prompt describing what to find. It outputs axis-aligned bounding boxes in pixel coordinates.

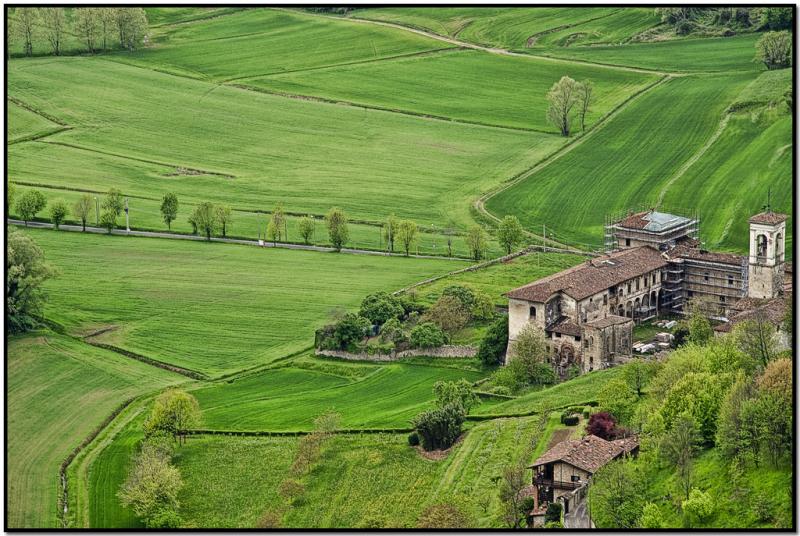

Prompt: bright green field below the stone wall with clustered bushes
[193,360,486,431]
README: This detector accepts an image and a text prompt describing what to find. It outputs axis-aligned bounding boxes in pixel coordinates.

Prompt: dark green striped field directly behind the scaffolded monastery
[486,74,764,251]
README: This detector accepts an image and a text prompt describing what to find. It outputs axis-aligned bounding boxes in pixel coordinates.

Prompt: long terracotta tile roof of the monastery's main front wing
[506,246,667,303]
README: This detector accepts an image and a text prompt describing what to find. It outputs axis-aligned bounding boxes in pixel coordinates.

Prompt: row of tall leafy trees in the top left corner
[6,7,148,57]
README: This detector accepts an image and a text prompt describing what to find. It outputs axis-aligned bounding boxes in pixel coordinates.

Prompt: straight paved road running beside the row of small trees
[8,219,469,262]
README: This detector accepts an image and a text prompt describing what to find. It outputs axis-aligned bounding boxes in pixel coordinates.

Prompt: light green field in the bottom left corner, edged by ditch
[6,332,185,528]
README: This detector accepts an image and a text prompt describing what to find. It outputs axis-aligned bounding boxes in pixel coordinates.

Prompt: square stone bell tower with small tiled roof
[747,208,788,299]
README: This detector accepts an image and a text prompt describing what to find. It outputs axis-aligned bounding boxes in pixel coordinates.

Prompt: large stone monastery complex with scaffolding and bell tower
[506,211,791,374]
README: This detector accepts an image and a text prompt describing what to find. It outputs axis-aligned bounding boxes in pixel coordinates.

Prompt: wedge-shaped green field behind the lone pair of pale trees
[246,51,656,133]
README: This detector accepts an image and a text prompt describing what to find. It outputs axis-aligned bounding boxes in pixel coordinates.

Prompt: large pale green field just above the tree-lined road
[9,58,563,226]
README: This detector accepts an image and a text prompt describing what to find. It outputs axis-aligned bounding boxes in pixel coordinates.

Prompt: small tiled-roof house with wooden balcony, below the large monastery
[526,435,639,526]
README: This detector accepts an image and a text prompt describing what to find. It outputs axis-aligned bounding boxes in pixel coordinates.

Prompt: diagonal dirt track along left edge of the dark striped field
[472,75,673,242]
